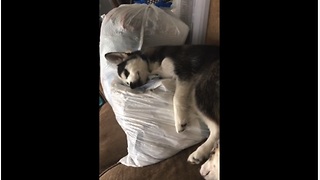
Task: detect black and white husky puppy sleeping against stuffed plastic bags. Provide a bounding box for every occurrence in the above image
[105,45,220,179]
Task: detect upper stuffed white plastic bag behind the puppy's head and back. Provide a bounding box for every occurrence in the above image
[100,4,189,105]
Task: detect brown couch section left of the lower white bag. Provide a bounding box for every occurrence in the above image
[99,102,127,173]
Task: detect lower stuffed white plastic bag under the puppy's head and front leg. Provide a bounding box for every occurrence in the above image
[109,78,209,167]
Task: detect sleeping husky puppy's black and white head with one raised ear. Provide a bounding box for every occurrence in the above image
[105,51,150,89]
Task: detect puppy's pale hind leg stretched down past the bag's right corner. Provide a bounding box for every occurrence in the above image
[188,112,219,164]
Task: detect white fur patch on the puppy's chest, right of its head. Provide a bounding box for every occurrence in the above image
[150,58,176,78]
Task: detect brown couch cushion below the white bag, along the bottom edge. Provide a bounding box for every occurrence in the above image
[100,143,203,180]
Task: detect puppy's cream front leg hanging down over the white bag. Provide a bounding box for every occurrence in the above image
[173,78,192,133]
